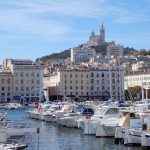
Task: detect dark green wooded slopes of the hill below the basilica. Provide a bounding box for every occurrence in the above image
[36,44,138,62]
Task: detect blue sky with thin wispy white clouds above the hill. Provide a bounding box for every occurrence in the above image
[0,0,150,64]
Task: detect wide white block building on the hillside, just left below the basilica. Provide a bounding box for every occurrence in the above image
[71,47,96,62]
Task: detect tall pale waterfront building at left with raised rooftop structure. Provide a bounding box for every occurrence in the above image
[4,59,43,101]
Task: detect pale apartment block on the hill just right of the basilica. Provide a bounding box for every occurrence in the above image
[107,43,124,58]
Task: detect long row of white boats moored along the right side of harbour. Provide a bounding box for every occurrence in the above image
[27,100,150,148]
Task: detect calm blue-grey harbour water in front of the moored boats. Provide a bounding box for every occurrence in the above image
[2,110,141,150]
